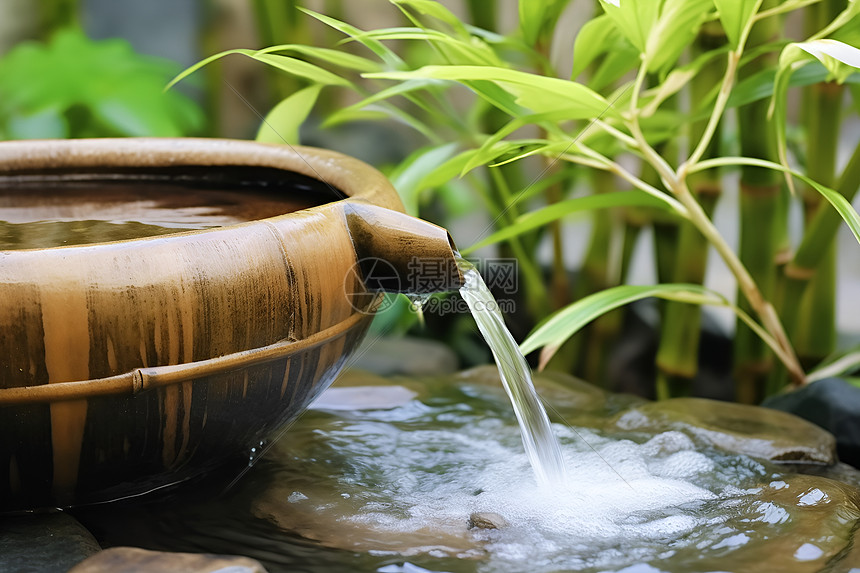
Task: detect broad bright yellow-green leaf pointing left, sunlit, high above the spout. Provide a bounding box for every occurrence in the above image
[366,66,618,119]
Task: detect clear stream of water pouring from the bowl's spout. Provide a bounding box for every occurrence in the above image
[457,255,564,485]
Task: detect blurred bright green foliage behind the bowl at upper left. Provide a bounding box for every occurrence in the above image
[0,29,203,139]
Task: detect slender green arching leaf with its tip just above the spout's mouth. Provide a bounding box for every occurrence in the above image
[462,190,671,255]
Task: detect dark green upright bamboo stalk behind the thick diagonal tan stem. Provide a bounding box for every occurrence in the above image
[734,0,784,404]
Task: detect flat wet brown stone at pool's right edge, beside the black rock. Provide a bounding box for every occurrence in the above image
[614,398,836,464]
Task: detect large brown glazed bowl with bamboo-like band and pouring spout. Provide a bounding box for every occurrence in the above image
[0,139,462,510]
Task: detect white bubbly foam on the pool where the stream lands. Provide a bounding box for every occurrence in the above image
[318,411,755,572]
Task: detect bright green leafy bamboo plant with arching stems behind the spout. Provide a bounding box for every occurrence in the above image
[177,0,860,402]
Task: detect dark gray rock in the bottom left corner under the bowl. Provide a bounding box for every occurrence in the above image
[0,512,101,573]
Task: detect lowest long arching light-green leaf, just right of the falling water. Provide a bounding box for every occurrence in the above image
[520,284,728,364]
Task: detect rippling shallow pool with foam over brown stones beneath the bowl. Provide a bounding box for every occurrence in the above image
[62,368,860,573]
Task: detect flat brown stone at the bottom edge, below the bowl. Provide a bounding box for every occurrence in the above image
[69,547,266,573]
